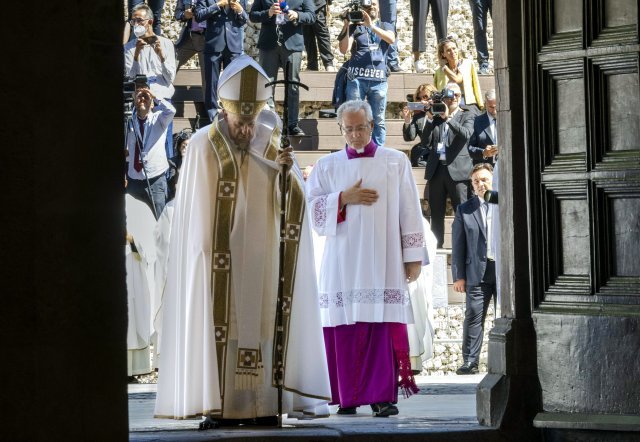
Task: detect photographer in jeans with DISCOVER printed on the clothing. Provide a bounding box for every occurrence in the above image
[338,0,396,146]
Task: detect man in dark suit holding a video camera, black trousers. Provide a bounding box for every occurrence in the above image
[422,83,474,248]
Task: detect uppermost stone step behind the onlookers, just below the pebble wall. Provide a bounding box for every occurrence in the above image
[173,69,495,103]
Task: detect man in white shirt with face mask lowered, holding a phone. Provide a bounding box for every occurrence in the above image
[124,4,176,158]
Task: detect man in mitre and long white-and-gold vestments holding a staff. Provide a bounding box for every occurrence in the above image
[155,56,331,426]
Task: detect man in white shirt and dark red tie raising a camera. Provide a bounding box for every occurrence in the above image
[127,88,176,219]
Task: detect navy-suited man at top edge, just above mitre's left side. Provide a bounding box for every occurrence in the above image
[195,0,249,121]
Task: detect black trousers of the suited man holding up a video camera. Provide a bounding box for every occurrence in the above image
[424,164,469,249]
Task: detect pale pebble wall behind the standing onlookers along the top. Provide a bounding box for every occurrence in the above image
[151,0,493,73]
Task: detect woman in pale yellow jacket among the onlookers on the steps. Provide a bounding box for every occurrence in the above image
[433,37,484,114]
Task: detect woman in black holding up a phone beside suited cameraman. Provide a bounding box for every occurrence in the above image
[402,83,437,167]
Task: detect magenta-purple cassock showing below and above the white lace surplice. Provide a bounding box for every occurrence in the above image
[323,141,419,408]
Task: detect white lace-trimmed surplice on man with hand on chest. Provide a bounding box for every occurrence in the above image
[307,147,429,327]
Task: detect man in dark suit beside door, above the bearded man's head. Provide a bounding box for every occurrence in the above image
[469,89,498,166]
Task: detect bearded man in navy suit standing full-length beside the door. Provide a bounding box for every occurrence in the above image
[451,163,497,374]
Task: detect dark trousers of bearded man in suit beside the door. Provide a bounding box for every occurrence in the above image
[462,261,497,365]
